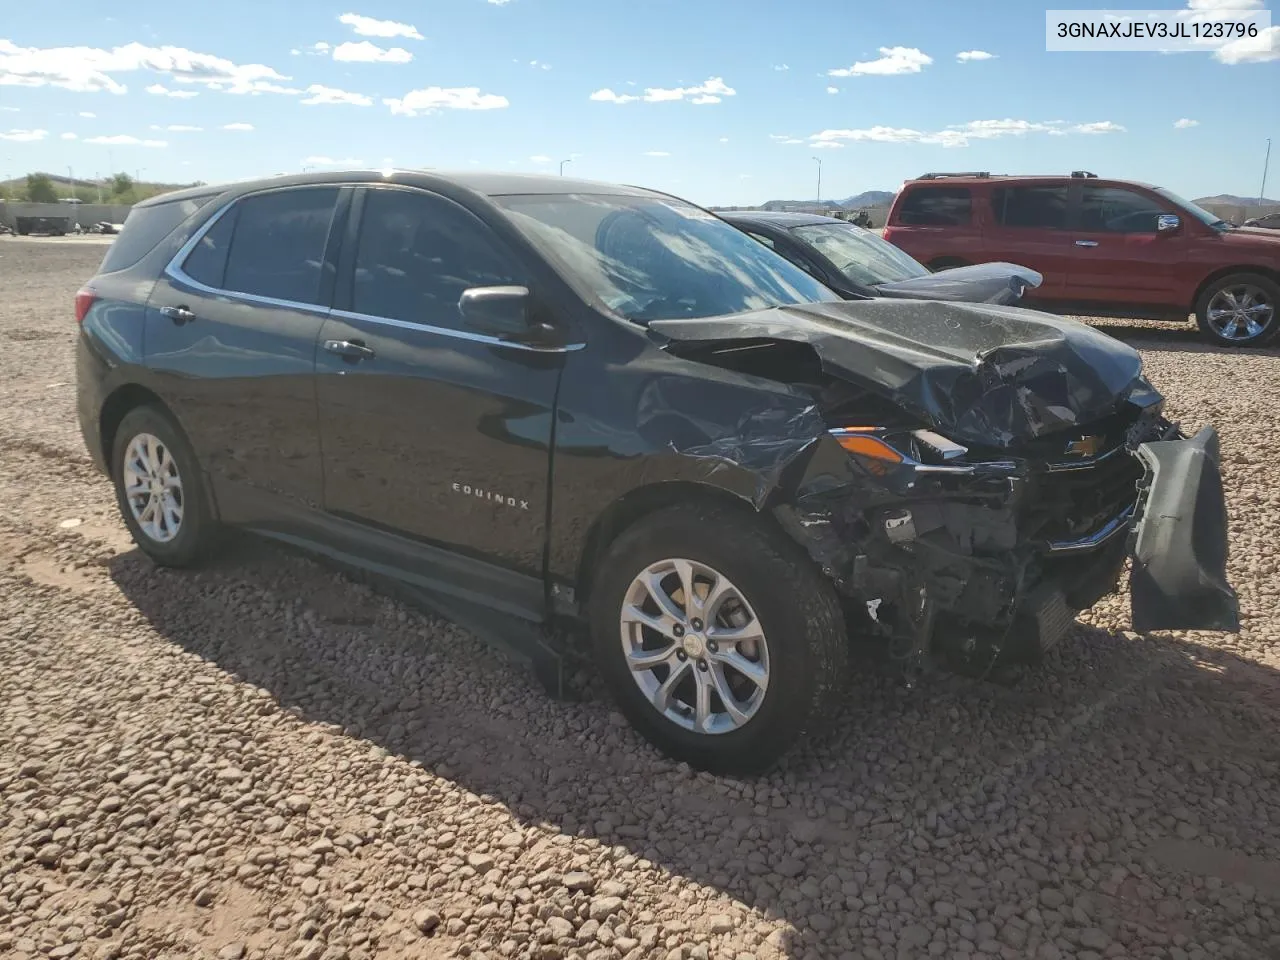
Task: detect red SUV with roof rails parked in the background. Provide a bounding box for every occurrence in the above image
[884,170,1280,347]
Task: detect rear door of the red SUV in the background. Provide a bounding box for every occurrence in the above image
[983,183,1073,303]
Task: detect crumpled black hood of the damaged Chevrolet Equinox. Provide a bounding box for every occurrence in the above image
[649,300,1142,447]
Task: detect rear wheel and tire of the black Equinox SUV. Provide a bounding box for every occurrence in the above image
[111,406,216,567]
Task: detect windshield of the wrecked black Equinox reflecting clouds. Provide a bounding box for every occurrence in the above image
[494,193,840,323]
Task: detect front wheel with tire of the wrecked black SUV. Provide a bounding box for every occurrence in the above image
[589,504,849,774]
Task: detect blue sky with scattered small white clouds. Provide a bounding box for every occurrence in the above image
[0,0,1280,205]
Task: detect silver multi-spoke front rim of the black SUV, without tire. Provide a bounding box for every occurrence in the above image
[621,558,769,733]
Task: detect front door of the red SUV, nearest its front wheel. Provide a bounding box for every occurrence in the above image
[1068,184,1188,307]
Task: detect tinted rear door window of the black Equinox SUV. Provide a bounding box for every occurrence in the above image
[219,187,339,303]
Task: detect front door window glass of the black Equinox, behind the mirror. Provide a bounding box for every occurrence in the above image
[351,189,525,330]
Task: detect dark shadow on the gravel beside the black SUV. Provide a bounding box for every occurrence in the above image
[109,536,1280,957]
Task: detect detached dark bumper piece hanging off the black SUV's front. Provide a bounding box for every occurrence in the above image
[1129,426,1240,634]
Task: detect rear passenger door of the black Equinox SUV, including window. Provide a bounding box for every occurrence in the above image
[145,186,344,522]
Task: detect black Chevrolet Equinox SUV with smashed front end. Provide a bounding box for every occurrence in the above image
[76,172,1238,772]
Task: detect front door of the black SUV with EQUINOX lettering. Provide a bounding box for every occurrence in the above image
[316,187,563,608]
